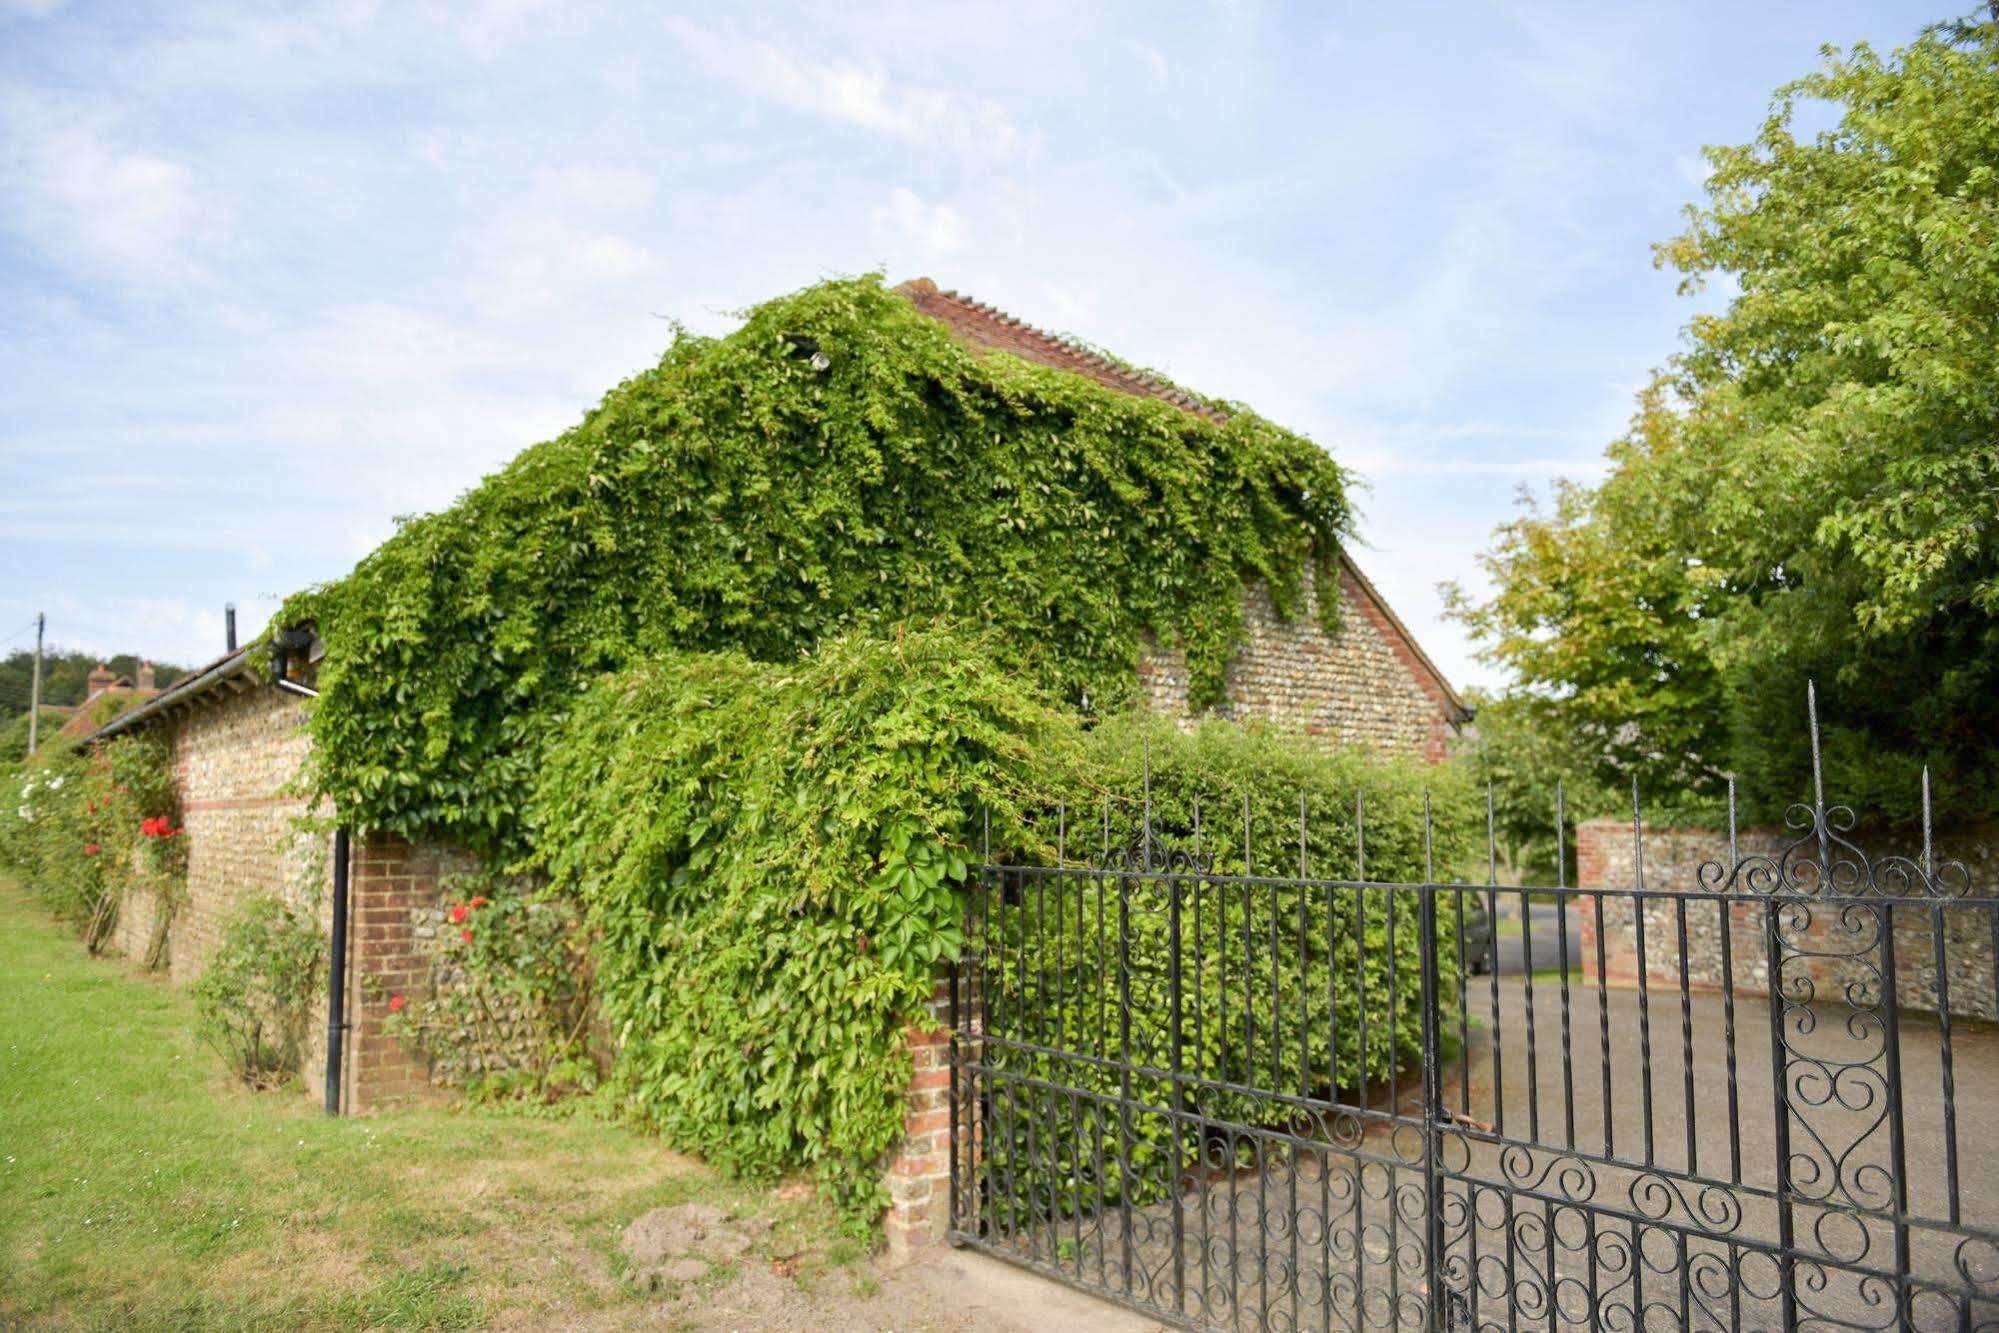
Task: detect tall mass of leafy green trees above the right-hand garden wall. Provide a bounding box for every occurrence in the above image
[1453,20,1999,817]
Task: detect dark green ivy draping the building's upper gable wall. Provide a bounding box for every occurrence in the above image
[289,276,1349,853]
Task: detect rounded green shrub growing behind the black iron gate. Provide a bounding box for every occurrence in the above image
[980,715,1479,1221]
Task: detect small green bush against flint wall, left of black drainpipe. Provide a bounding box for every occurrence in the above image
[190,897,326,1087]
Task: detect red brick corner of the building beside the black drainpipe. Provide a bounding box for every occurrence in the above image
[346,837,440,1113]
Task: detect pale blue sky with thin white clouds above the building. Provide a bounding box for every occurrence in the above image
[0,0,1951,683]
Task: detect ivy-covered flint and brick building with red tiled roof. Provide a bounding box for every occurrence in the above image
[77,280,1469,1223]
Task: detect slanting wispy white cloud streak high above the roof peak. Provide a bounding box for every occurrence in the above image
[668,18,1037,162]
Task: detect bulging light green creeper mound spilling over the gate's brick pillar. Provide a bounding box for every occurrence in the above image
[530,630,1073,1231]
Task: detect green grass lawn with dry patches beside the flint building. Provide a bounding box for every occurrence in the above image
[0,877,870,1331]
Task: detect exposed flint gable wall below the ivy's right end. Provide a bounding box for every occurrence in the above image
[1137,570,1451,761]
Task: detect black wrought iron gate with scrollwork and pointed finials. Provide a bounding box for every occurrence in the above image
[950,695,1999,1329]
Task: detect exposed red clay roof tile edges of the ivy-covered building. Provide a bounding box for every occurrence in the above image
[896,278,1471,723]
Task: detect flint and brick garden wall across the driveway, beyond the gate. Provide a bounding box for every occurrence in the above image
[1575,819,1999,1019]
